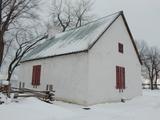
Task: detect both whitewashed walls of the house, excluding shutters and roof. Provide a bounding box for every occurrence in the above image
[19,12,142,105]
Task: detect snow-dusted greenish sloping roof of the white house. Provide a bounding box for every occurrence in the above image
[22,12,121,61]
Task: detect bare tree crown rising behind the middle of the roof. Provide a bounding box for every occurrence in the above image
[52,0,93,32]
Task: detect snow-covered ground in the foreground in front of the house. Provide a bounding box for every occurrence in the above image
[0,90,160,120]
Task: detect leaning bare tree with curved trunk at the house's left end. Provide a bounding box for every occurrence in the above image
[4,31,48,97]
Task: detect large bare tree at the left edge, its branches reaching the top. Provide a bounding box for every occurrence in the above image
[0,0,37,65]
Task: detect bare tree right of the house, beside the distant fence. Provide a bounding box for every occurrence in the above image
[137,41,160,90]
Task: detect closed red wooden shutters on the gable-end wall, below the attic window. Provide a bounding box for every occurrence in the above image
[116,66,125,90]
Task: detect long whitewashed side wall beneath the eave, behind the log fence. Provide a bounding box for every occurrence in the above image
[20,53,88,104]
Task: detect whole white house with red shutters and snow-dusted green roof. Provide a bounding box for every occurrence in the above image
[19,11,142,105]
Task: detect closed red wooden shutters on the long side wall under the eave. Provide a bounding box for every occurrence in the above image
[32,65,41,86]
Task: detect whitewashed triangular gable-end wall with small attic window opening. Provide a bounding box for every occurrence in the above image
[88,16,142,104]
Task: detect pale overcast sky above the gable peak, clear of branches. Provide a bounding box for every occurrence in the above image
[40,0,160,47]
